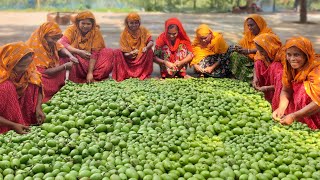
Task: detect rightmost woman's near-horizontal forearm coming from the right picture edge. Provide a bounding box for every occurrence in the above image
[280,101,320,125]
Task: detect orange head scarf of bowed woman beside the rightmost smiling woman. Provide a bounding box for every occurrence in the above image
[253,33,281,66]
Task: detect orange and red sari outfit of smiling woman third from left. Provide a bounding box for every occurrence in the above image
[60,11,113,83]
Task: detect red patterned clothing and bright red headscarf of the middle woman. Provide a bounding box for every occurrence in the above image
[155,18,193,78]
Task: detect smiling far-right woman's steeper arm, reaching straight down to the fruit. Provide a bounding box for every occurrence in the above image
[272,86,293,120]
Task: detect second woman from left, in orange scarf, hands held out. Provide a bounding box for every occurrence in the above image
[26,22,78,102]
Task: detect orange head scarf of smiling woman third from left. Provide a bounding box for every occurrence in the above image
[63,11,105,52]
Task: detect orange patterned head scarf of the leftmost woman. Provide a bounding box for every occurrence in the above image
[0,42,41,96]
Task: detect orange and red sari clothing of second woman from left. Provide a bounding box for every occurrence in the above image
[26,22,66,102]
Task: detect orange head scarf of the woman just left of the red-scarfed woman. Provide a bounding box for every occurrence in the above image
[120,13,151,58]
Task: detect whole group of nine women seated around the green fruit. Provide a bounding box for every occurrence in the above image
[0,11,320,133]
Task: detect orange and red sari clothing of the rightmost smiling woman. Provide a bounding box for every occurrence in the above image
[282,37,320,129]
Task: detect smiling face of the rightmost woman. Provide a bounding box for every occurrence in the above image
[286,46,308,70]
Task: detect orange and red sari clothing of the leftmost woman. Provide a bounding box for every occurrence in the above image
[0,42,41,133]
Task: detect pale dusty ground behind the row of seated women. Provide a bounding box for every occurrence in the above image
[0,12,320,75]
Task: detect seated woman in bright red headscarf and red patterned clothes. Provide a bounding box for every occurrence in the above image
[154,18,193,78]
